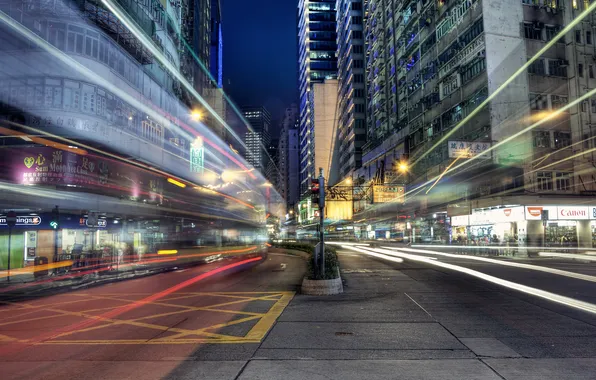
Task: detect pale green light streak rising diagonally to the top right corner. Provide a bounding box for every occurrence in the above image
[412,2,596,166]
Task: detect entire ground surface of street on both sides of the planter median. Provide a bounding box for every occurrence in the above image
[0,250,596,380]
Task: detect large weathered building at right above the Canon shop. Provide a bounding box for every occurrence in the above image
[361,0,596,245]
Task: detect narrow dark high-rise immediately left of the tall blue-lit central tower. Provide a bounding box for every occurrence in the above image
[278,104,300,209]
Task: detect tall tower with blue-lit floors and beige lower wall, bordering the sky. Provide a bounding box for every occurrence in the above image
[297,0,337,194]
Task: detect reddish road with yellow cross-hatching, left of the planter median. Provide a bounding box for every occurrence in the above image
[0,255,306,379]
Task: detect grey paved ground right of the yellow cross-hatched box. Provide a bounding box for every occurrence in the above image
[224,251,596,380]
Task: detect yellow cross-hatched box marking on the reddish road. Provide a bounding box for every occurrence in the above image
[0,291,294,345]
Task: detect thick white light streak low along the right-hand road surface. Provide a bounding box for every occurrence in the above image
[358,248,596,314]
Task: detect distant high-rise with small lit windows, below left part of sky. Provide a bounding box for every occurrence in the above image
[242,107,271,175]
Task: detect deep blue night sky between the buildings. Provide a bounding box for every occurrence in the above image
[221,0,297,136]
